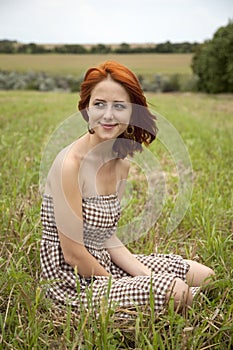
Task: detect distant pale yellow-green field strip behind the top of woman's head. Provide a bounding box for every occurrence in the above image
[0,54,192,76]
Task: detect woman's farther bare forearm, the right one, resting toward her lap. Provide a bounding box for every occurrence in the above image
[106,235,151,276]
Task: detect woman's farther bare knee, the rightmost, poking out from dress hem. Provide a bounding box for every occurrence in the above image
[186,260,215,287]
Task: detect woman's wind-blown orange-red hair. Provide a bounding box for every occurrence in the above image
[78,61,158,158]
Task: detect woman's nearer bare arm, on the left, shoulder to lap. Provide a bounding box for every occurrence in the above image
[50,150,110,278]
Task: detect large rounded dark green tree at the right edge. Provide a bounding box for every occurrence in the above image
[192,21,233,93]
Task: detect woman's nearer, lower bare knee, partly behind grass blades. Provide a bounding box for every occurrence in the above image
[166,277,193,310]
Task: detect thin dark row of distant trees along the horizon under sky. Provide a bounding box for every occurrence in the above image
[0,40,200,54]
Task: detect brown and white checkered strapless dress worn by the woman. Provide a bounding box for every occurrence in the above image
[41,194,195,312]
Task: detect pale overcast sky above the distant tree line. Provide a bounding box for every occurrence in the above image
[0,0,233,44]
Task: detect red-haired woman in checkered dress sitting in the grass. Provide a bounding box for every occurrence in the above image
[41,61,214,312]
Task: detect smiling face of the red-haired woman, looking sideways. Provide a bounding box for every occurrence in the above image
[87,77,132,140]
